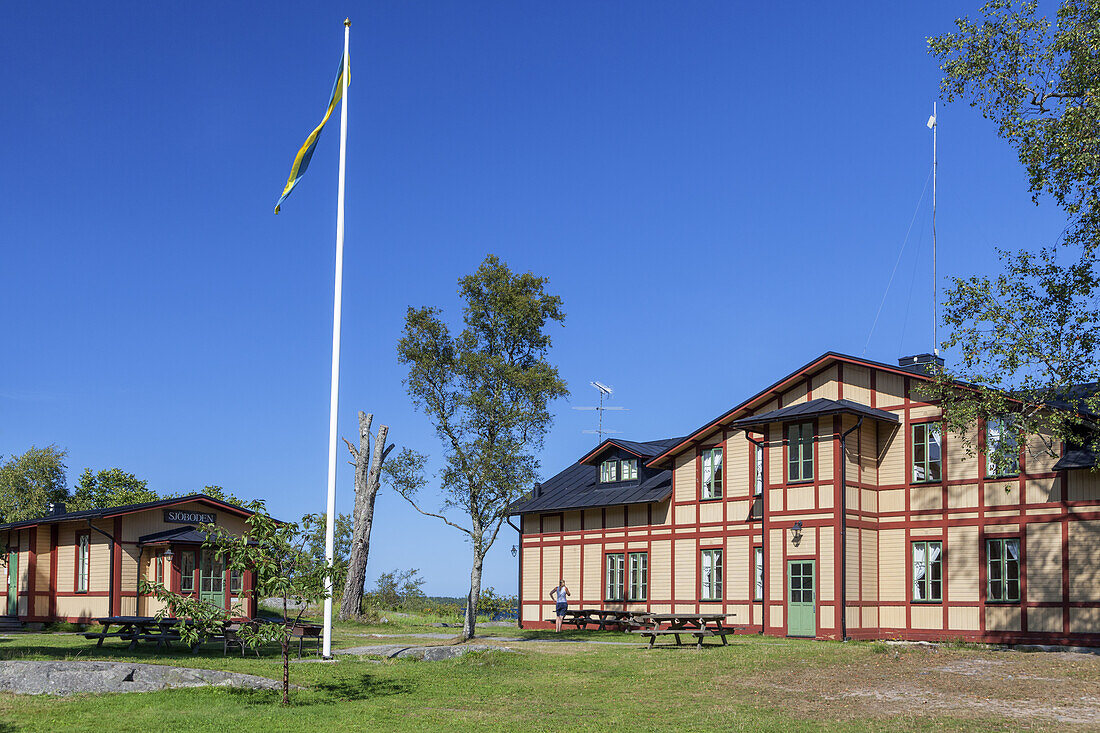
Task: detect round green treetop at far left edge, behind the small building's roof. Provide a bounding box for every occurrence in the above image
[0,445,68,522]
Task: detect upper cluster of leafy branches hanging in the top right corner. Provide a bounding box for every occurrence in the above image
[928,0,1100,252]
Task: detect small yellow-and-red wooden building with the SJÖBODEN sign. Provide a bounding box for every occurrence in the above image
[0,494,256,623]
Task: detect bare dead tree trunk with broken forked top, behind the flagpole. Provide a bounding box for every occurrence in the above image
[340,411,393,621]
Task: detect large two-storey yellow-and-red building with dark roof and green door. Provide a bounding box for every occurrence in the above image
[513,352,1100,645]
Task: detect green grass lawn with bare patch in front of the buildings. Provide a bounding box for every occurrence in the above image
[0,617,1100,732]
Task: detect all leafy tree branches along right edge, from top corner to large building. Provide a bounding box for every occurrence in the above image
[926,0,1100,453]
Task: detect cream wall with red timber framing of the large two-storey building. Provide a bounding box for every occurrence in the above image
[520,359,1100,643]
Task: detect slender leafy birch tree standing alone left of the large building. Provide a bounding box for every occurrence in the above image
[386,254,568,641]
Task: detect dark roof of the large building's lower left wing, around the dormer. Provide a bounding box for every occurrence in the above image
[509,438,680,514]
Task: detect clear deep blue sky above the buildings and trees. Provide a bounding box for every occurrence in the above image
[0,1,1064,594]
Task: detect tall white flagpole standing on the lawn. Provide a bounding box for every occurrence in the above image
[321,19,351,659]
